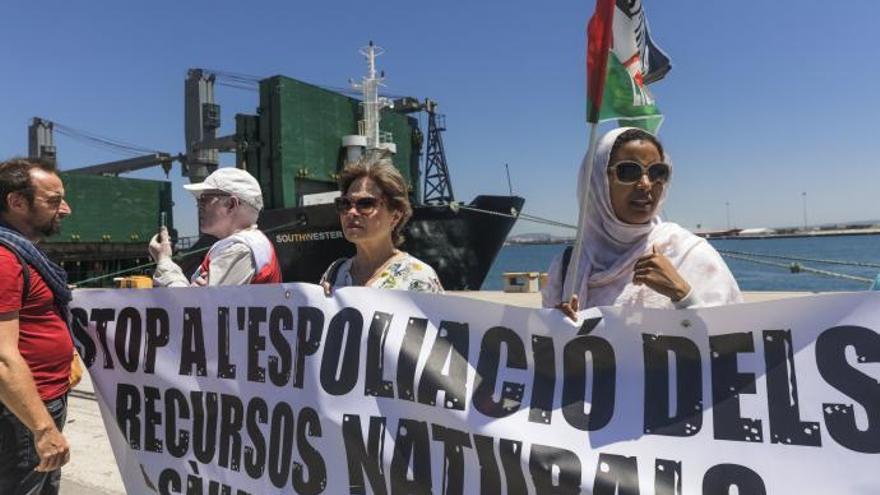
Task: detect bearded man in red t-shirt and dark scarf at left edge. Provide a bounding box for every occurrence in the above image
[0,159,73,495]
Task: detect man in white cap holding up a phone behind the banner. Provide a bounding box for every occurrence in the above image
[150,168,281,287]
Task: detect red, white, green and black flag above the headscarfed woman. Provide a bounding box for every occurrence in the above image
[587,0,672,131]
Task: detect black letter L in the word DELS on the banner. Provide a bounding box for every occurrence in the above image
[764,330,822,447]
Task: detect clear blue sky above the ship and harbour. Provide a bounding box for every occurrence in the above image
[0,0,880,238]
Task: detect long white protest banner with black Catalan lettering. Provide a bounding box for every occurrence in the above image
[72,284,880,495]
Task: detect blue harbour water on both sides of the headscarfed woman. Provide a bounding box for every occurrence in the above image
[483,235,880,292]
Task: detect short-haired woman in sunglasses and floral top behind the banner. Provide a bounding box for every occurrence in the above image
[321,154,443,294]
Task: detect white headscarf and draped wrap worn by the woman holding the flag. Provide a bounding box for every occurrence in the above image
[543,127,741,308]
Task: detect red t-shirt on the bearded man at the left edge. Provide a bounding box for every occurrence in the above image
[0,246,73,400]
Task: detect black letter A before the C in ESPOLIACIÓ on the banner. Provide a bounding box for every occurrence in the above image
[419,321,470,411]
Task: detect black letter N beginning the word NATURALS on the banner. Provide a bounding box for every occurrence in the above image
[342,414,386,495]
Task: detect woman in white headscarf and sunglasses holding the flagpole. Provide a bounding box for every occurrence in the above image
[542,128,742,319]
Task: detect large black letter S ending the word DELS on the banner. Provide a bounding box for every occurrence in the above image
[816,325,880,454]
